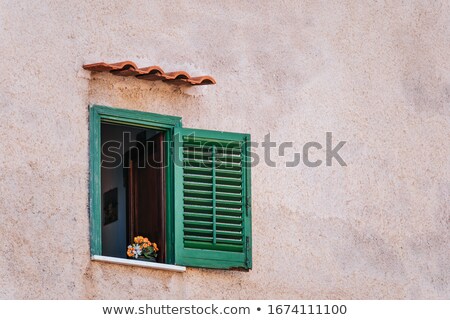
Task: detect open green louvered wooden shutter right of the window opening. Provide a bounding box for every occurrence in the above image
[174,128,251,269]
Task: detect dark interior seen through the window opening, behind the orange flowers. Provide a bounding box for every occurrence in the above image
[101,122,166,262]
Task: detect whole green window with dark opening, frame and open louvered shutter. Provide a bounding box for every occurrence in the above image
[90,106,251,269]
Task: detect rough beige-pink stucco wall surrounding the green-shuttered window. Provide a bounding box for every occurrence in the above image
[0,1,450,299]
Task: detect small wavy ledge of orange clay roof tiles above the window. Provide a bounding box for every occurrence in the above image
[83,61,216,86]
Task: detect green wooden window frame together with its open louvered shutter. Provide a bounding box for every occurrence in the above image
[89,105,252,270]
